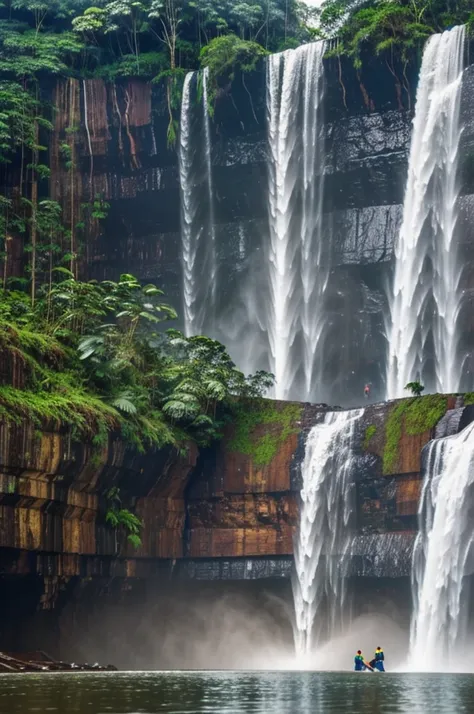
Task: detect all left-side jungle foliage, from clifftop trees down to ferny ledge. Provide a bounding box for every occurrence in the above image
[0,5,282,545]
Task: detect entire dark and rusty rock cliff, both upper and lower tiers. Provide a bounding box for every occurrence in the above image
[0,47,474,652]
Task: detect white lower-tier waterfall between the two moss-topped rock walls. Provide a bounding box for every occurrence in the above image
[293,409,364,656]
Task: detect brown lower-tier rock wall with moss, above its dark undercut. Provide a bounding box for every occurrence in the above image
[0,395,472,584]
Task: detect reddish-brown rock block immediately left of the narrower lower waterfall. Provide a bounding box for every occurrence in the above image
[187,402,302,558]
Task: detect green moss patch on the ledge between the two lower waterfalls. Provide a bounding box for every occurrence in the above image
[383,394,447,474]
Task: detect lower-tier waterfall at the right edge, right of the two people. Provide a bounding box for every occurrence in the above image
[410,422,474,671]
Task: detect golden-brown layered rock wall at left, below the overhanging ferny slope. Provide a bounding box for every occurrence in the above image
[0,424,197,574]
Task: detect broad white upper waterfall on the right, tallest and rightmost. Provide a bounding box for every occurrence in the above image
[387,27,465,399]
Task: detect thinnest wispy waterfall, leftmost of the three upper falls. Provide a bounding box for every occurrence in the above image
[179,70,217,336]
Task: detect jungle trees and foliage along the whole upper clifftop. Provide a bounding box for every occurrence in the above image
[0,0,468,156]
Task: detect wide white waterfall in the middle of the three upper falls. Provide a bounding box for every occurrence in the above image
[266,42,328,399]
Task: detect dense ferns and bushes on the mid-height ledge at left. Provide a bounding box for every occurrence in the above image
[0,269,272,450]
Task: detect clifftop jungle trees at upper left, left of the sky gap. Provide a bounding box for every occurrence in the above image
[0,0,313,152]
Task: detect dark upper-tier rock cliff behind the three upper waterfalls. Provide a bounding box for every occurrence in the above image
[37,51,474,406]
